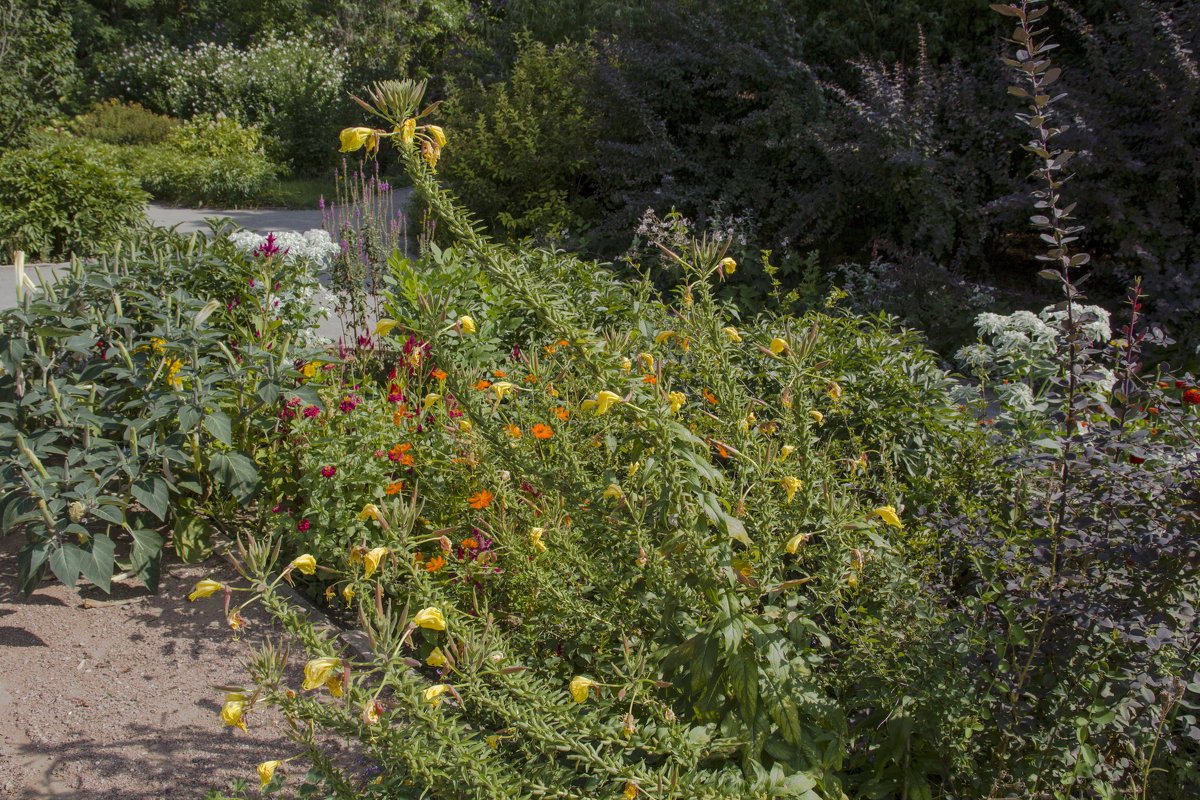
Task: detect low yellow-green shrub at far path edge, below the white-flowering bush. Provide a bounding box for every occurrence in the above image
[136,118,282,206]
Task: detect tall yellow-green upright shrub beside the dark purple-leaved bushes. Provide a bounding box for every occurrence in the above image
[443,38,599,241]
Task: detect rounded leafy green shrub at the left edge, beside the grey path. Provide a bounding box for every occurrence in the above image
[0,138,148,259]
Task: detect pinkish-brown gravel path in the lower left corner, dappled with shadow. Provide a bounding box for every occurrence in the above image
[0,536,302,800]
